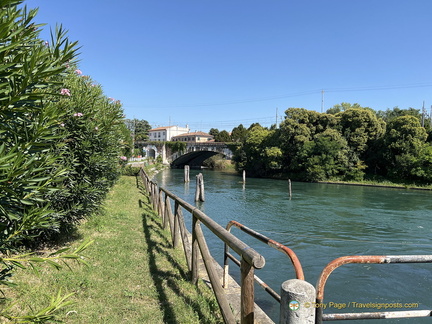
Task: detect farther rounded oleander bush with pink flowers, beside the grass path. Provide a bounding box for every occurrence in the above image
[48,66,132,227]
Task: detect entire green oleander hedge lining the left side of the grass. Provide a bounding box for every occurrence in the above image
[0,0,131,321]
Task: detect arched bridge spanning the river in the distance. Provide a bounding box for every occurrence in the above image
[143,142,233,168]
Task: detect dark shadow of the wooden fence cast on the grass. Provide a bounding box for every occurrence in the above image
[140,201,222,323]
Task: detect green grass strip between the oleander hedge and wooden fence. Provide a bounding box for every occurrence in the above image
[5,176,223,324]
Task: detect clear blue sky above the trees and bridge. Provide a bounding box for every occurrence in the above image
[24,0,432,131]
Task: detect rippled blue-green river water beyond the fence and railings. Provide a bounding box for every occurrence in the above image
[155,170,432,324]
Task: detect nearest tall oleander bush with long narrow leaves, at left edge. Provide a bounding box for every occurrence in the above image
[0,0,76,248]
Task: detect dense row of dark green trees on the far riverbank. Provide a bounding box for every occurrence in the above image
[211,103,432,184]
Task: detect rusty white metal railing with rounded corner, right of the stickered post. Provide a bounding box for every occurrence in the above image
[316,255,432,324]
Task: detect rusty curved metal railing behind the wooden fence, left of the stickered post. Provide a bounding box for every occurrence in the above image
[223,220,304,303]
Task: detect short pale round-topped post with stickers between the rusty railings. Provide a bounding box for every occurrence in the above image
[279,279,316,324]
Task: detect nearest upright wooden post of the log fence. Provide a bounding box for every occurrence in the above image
[240,257,255,324]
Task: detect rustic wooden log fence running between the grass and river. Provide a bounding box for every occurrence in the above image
[139,168,265,324]
